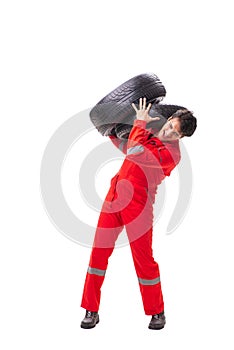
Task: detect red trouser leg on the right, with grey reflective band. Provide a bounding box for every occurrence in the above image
[127,228,164,315]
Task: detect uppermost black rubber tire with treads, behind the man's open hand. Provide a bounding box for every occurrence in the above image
[90,73,166,136]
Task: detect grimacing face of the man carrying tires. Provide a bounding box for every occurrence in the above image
[156,117,182,141]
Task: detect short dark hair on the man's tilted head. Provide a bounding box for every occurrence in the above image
[172,109,197,136]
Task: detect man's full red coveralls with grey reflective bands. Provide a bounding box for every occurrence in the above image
[81,120,180,315]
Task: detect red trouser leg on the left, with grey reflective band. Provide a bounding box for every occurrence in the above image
[81,206,123,311]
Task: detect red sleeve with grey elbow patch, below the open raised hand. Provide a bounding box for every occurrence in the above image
[127,120,180,175]
